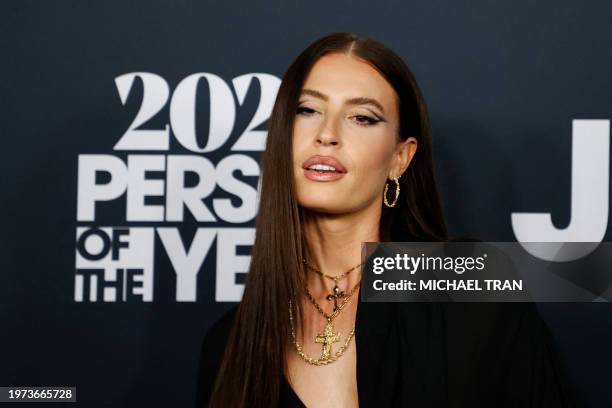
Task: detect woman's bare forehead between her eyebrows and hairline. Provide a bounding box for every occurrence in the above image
[303,54,396,112]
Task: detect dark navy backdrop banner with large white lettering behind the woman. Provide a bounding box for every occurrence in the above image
[0,0,612,407]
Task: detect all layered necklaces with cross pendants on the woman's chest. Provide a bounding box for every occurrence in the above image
[289,259,363,365]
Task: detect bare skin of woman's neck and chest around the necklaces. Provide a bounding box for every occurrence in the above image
[287,201,381,408]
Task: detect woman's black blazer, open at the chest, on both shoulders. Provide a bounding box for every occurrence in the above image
[197,297,575,408]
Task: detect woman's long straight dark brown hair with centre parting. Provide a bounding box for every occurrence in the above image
[210,33,447,408]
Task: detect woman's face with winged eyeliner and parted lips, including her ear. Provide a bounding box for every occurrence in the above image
[293,54,416,214]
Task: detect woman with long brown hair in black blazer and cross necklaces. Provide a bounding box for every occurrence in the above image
[198,33,571,407]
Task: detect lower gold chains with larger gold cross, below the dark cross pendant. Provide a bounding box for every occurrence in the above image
[289,281,361,366]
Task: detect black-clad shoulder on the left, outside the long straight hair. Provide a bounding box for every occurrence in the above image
[196,305,238,408]
